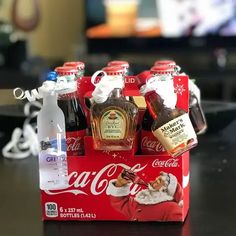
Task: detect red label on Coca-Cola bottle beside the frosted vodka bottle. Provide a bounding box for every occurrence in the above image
[66,129,86,156]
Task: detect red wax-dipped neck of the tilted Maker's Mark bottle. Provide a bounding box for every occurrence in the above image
[145,90,168,120]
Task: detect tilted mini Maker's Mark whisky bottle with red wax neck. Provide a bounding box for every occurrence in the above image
[145,91,197,157]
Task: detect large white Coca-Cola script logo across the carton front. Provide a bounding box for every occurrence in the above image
[45,163,147,195]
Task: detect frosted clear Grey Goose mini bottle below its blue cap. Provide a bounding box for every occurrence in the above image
[37,90,68,190]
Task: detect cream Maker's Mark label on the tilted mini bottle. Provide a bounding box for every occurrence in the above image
[153,113,197,155]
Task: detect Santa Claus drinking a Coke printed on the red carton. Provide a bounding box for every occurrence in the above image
[109,170,183,221]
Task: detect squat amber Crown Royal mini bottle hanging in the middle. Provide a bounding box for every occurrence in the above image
[91,88,138,150]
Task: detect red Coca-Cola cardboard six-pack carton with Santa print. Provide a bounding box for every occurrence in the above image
[41,76,189,222]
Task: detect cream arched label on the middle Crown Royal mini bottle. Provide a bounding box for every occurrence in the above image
[100,109,126,140]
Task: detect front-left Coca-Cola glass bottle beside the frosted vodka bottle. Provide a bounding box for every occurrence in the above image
[55,66,88,156]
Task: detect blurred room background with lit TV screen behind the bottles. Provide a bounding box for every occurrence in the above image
[0,0,236,137]
